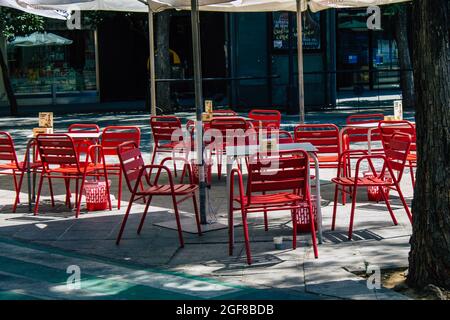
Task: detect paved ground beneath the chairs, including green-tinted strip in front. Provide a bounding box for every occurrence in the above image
[0,113,413,299]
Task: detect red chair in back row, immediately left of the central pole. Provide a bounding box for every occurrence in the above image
[150,116,187,177]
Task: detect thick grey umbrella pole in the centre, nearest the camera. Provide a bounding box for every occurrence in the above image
[191,0,207,224]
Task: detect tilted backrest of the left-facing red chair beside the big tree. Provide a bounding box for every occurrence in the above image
[383,132,411,181]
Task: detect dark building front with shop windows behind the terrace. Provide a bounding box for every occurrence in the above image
[0,10,400,113]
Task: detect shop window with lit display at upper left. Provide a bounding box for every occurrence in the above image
[8,30,96,94]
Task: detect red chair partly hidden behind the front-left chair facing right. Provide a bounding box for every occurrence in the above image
[101,126,141,210]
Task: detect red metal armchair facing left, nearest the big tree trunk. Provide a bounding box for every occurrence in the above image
[331,133,412,240]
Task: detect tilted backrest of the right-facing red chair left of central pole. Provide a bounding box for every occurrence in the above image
[116,141,145,192]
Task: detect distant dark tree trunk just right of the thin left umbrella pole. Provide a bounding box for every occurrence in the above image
[155,11,172,113]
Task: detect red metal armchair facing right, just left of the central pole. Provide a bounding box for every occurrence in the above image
[116,142,201,247]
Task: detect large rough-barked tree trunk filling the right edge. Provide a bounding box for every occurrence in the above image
[408,0,450,288]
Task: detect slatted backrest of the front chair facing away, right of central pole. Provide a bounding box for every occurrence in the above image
[247,150,309,199]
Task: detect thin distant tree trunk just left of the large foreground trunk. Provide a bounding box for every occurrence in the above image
[395,5,414,107]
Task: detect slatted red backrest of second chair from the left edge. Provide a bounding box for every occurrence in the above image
[36,134,80,171]
